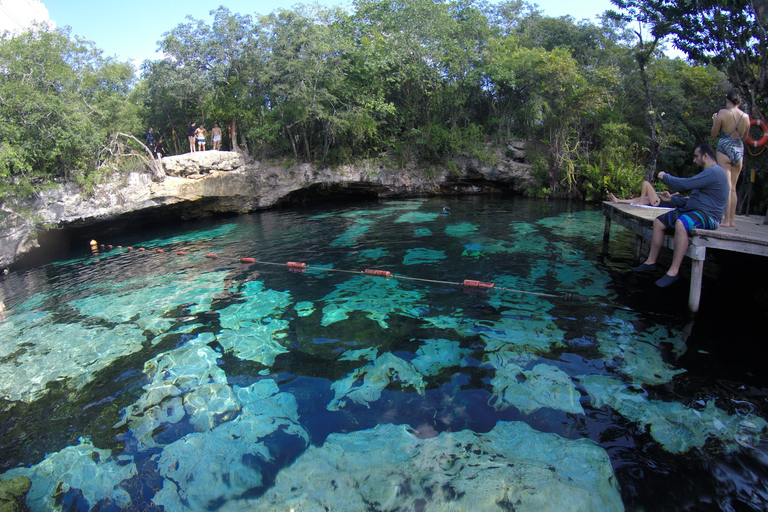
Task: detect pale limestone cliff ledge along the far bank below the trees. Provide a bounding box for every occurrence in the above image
[0,143,530,267]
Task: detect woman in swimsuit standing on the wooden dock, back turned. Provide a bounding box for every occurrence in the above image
[712,92,749,228]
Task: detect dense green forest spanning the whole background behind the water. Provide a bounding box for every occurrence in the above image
[0,0,768,211]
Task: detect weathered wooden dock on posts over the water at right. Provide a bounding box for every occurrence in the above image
[603,201,768,312]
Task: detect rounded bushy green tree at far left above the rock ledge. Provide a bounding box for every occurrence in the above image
[0,29,133,202]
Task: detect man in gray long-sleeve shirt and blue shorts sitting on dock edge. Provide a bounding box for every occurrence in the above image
[632,144,730,288]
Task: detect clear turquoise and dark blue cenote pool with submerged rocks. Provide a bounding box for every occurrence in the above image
[0,198,768,512]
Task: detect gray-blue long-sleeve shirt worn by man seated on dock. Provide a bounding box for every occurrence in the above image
[662,164,730,223]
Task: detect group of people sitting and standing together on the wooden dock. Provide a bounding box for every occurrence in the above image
[610,92,750,288]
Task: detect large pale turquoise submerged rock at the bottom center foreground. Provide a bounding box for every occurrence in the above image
[220,422,624,512]
